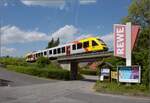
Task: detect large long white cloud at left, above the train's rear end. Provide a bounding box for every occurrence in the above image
[1,25,49,44]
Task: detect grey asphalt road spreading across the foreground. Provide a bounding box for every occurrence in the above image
[0,69,150,103]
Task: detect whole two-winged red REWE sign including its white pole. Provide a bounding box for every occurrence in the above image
[114,22,140,66]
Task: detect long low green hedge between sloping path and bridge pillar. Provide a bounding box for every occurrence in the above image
[7,65,70,80]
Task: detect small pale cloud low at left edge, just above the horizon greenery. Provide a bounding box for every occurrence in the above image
[1,47,17,56]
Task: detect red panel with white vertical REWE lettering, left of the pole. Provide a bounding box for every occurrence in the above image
[114,24,126,58]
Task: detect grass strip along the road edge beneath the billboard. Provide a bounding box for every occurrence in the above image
[94,81,150,96]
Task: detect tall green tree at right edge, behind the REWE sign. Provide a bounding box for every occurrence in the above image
[122,0,150,87]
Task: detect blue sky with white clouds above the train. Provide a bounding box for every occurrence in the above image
[0,0,131,57]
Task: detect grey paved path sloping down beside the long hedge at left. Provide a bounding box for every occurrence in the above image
[0,67,57,86]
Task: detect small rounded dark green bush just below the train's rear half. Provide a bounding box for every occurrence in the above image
[36,57,50,68]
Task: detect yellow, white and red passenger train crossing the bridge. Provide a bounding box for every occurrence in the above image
[25,37,108,62]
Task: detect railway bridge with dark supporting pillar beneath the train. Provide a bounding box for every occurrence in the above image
[57,51,113,80]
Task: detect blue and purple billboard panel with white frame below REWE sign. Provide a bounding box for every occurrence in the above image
[118,66,141,83]
